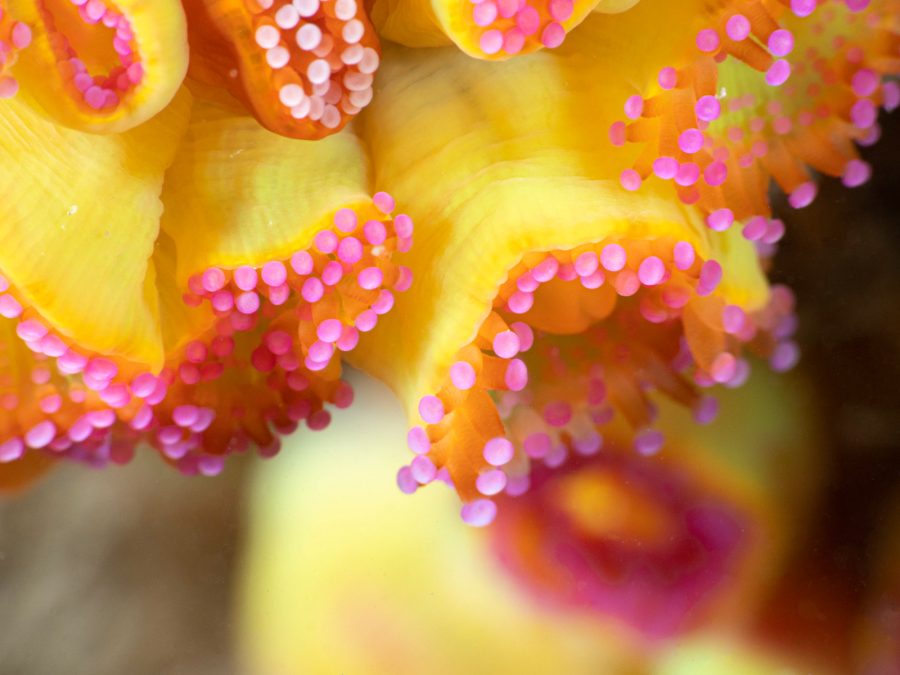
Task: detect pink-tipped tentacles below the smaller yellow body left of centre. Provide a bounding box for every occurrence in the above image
[153,192,412,473]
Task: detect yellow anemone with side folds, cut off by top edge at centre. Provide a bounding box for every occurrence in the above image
[372,0,638,61]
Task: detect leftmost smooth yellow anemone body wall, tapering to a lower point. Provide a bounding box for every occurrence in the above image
[0,92,190,369]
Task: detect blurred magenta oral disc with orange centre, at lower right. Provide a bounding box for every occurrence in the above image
[489,443,764,639]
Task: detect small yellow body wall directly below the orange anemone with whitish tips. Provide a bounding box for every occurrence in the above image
[162,84,374,286]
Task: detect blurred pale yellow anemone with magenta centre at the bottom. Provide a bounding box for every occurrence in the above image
[237,373,819,675]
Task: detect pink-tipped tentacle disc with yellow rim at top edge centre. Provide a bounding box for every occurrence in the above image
[436,0,597,60]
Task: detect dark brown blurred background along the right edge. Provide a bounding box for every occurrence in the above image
[752,115,900,672]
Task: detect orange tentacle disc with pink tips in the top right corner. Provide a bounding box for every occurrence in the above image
[609,0,900,230]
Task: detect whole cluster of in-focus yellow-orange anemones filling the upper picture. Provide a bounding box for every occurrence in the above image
[0,0,900,544]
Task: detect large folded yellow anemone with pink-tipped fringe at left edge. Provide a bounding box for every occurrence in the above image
[0,85,412,486]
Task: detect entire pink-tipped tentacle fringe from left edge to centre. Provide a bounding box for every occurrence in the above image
[0,193,412,475]
